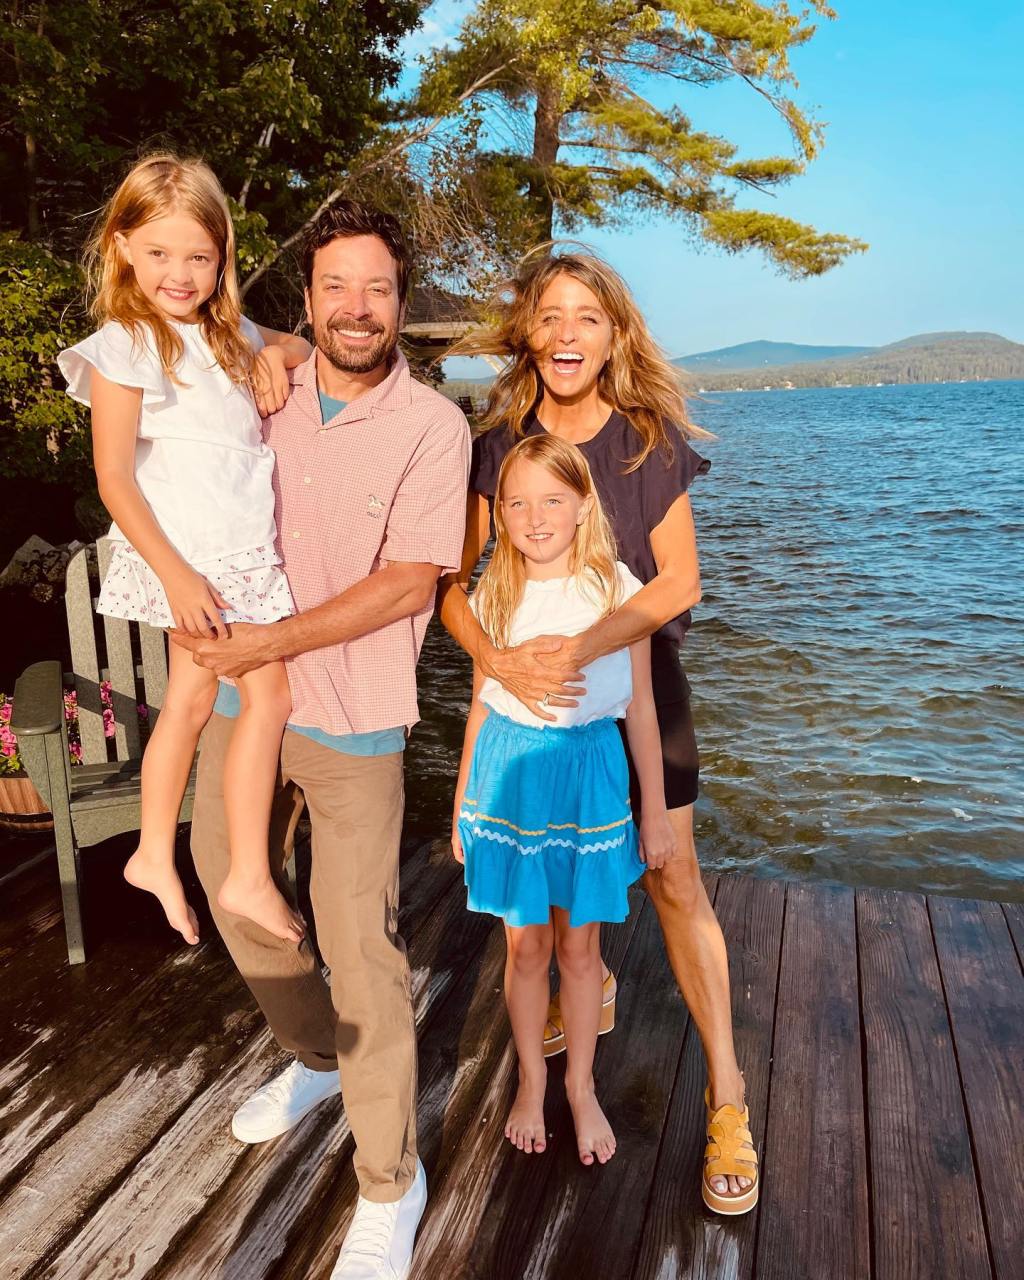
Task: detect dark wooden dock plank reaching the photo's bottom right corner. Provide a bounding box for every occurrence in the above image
[928,897,1024,1280]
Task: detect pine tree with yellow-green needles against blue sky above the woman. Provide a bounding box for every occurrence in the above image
[411,0,865,276]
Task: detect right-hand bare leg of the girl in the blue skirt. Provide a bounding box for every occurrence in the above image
[553,908,616,1165]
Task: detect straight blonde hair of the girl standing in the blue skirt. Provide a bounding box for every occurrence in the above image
[476,435,621,649]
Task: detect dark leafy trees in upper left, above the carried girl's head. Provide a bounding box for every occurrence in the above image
[0,0,419,305]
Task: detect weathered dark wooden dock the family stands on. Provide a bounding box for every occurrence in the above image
[0,824,1024,1280]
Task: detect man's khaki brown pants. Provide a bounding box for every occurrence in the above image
[192,716,416,1203]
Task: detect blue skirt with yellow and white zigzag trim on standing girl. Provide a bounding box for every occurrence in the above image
[458,712,645,928]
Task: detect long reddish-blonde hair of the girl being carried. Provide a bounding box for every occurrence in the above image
[86,152,253,384]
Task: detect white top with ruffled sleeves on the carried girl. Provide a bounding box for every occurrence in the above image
[58,319,276,567]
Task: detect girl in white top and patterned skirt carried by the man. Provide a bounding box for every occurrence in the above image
[59,155,310,943]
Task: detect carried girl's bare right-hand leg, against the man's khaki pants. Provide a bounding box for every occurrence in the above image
[216,662,305,942]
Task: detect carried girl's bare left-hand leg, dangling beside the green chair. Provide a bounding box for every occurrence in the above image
[124,645,216,946]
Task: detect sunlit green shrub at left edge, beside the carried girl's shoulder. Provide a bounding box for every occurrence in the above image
[0,233,90,483]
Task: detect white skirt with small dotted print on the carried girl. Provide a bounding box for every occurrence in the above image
[96,543,296,627]
